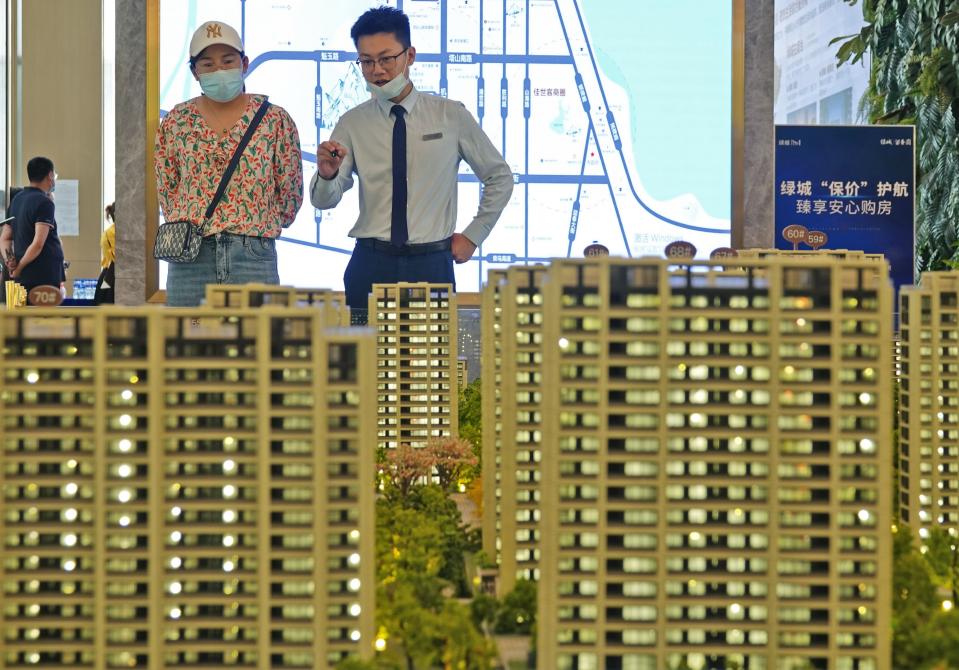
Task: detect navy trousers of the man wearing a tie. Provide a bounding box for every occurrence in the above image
[343,245,456,311]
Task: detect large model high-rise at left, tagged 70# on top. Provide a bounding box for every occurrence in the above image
[0,306,375,669]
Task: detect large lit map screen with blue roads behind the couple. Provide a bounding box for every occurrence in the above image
[160,0,733,291]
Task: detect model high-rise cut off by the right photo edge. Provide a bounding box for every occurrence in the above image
[899,272,959,538]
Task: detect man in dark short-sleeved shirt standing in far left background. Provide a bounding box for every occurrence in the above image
[7,156,64,291]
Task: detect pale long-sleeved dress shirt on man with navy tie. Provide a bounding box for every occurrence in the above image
[310,88,513,246]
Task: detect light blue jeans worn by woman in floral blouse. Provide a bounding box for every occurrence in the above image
[166,233,280,307]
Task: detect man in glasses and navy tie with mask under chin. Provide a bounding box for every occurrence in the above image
[310,6,513,318]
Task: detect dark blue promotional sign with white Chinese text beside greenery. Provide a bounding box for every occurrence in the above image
[775,126,916,288]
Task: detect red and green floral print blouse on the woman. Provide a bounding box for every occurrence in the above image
[154,95,303,237]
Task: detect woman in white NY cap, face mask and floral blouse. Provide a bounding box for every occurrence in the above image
[154,21,303,306]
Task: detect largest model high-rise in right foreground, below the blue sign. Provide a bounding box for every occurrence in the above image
[496,256,892,670]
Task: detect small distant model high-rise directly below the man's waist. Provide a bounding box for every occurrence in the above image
[369,283,459,448]
